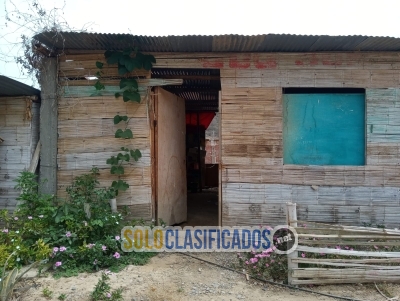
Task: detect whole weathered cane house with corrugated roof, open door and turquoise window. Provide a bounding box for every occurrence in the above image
[35,32,400,227]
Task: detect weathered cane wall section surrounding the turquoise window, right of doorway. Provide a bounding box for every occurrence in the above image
[219,53,400,227]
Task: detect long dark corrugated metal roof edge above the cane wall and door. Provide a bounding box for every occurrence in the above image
[34,32,400,52]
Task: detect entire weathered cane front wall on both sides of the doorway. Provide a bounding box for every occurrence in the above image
[58,52,400,226]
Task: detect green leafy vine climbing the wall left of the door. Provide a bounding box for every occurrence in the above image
[94,49,156,196]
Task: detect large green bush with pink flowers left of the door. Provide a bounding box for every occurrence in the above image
[0,168,152,275]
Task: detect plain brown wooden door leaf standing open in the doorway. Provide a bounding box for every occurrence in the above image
[155,87,187,225]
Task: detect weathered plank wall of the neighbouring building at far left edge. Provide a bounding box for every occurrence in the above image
[0,97,40,211]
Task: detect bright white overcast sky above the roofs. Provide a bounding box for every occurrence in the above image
[0,0,400,89]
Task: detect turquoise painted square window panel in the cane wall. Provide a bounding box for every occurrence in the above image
[283,93,365,165]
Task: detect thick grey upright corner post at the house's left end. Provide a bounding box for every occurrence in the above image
[39,58,58,195]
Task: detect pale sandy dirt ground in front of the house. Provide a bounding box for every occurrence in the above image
[19,253,400,301]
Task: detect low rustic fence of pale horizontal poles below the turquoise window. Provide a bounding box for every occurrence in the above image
[286,203,400,285]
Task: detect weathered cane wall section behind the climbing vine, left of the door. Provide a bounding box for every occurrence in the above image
[57,54,152,220]
